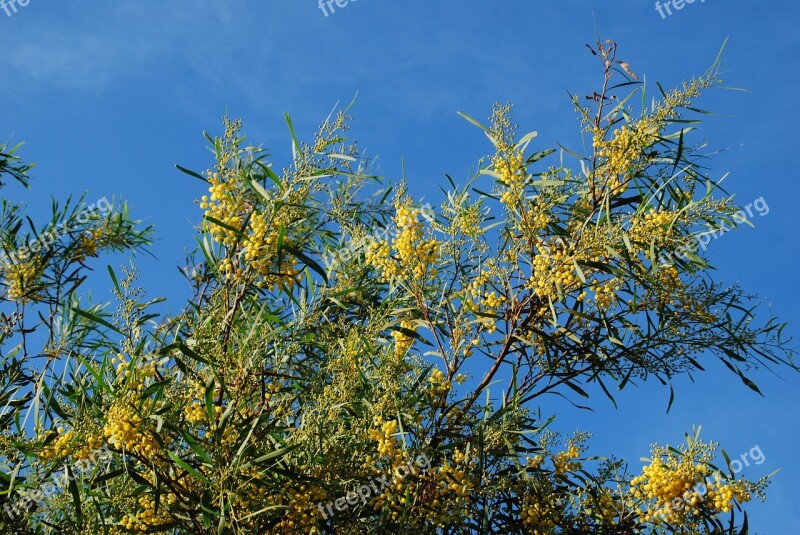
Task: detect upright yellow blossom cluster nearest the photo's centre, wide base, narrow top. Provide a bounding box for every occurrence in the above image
[366,198,440,280]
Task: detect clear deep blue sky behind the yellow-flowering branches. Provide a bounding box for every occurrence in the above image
[0,0,800,535]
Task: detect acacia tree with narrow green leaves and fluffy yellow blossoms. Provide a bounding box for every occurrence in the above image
[0,41,794,535]
